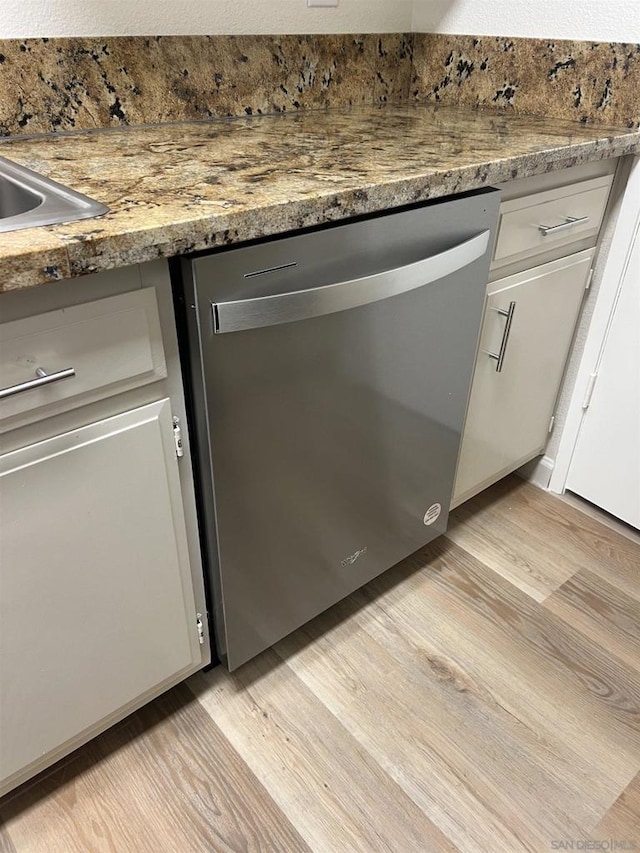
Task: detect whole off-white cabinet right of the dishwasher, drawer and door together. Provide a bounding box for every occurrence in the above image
[451,160,617,507]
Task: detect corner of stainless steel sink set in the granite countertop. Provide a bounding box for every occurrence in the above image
[0,157,109,232]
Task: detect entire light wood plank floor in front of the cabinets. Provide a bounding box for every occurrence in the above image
[0,477,640,853]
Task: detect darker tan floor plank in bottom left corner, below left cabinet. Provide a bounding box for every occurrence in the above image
[0,685,309,853]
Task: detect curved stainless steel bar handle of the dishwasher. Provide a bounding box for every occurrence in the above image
[211,231,491,334]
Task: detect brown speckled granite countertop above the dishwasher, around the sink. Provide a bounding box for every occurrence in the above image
[0,104,640,292]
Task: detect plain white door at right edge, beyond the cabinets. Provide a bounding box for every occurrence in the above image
[566,229,640,528]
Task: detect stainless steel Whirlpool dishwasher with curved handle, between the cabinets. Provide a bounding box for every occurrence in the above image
[176,189,499,669]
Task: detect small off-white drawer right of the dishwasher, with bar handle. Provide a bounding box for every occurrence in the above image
[494,175,613,266]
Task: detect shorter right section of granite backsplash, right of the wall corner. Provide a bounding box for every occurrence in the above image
[411,33,640,127]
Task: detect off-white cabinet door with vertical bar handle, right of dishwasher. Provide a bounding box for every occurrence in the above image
[452,250,593,506]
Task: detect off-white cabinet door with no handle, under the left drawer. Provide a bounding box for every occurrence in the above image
[0,400,201,787]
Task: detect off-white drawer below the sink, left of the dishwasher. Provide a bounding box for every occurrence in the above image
[0,288,167,431]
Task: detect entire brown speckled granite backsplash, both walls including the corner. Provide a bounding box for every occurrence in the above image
[0,33,640,136]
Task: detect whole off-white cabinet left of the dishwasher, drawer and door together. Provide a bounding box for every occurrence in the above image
[0,262,210,795]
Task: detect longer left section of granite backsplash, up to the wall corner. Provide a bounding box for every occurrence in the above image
[0,33,413,136]
